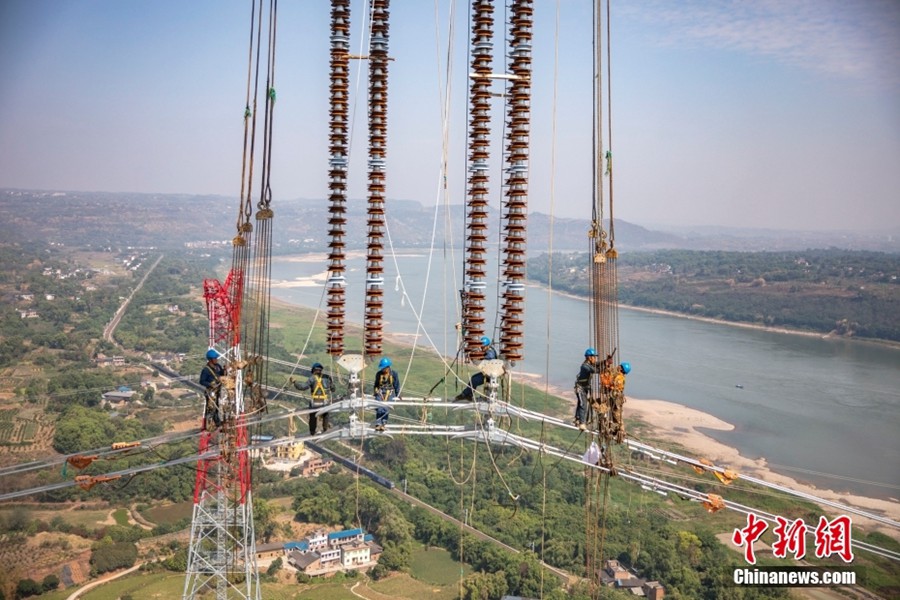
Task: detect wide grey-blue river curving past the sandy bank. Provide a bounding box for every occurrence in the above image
[272,251,900,499]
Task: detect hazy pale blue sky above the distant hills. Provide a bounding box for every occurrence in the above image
[0,0,900,231]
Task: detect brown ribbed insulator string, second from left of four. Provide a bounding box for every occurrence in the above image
[363,0,390,358]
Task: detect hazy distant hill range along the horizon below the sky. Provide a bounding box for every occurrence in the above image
[0,189,900,254]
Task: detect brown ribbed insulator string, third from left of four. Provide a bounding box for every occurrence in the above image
[462,0,494,362]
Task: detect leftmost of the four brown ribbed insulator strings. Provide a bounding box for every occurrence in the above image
[325,0,350,356]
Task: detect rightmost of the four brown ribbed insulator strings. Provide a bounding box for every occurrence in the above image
[500,0,534,365]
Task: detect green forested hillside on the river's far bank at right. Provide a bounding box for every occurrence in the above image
[528,249,900,341]
